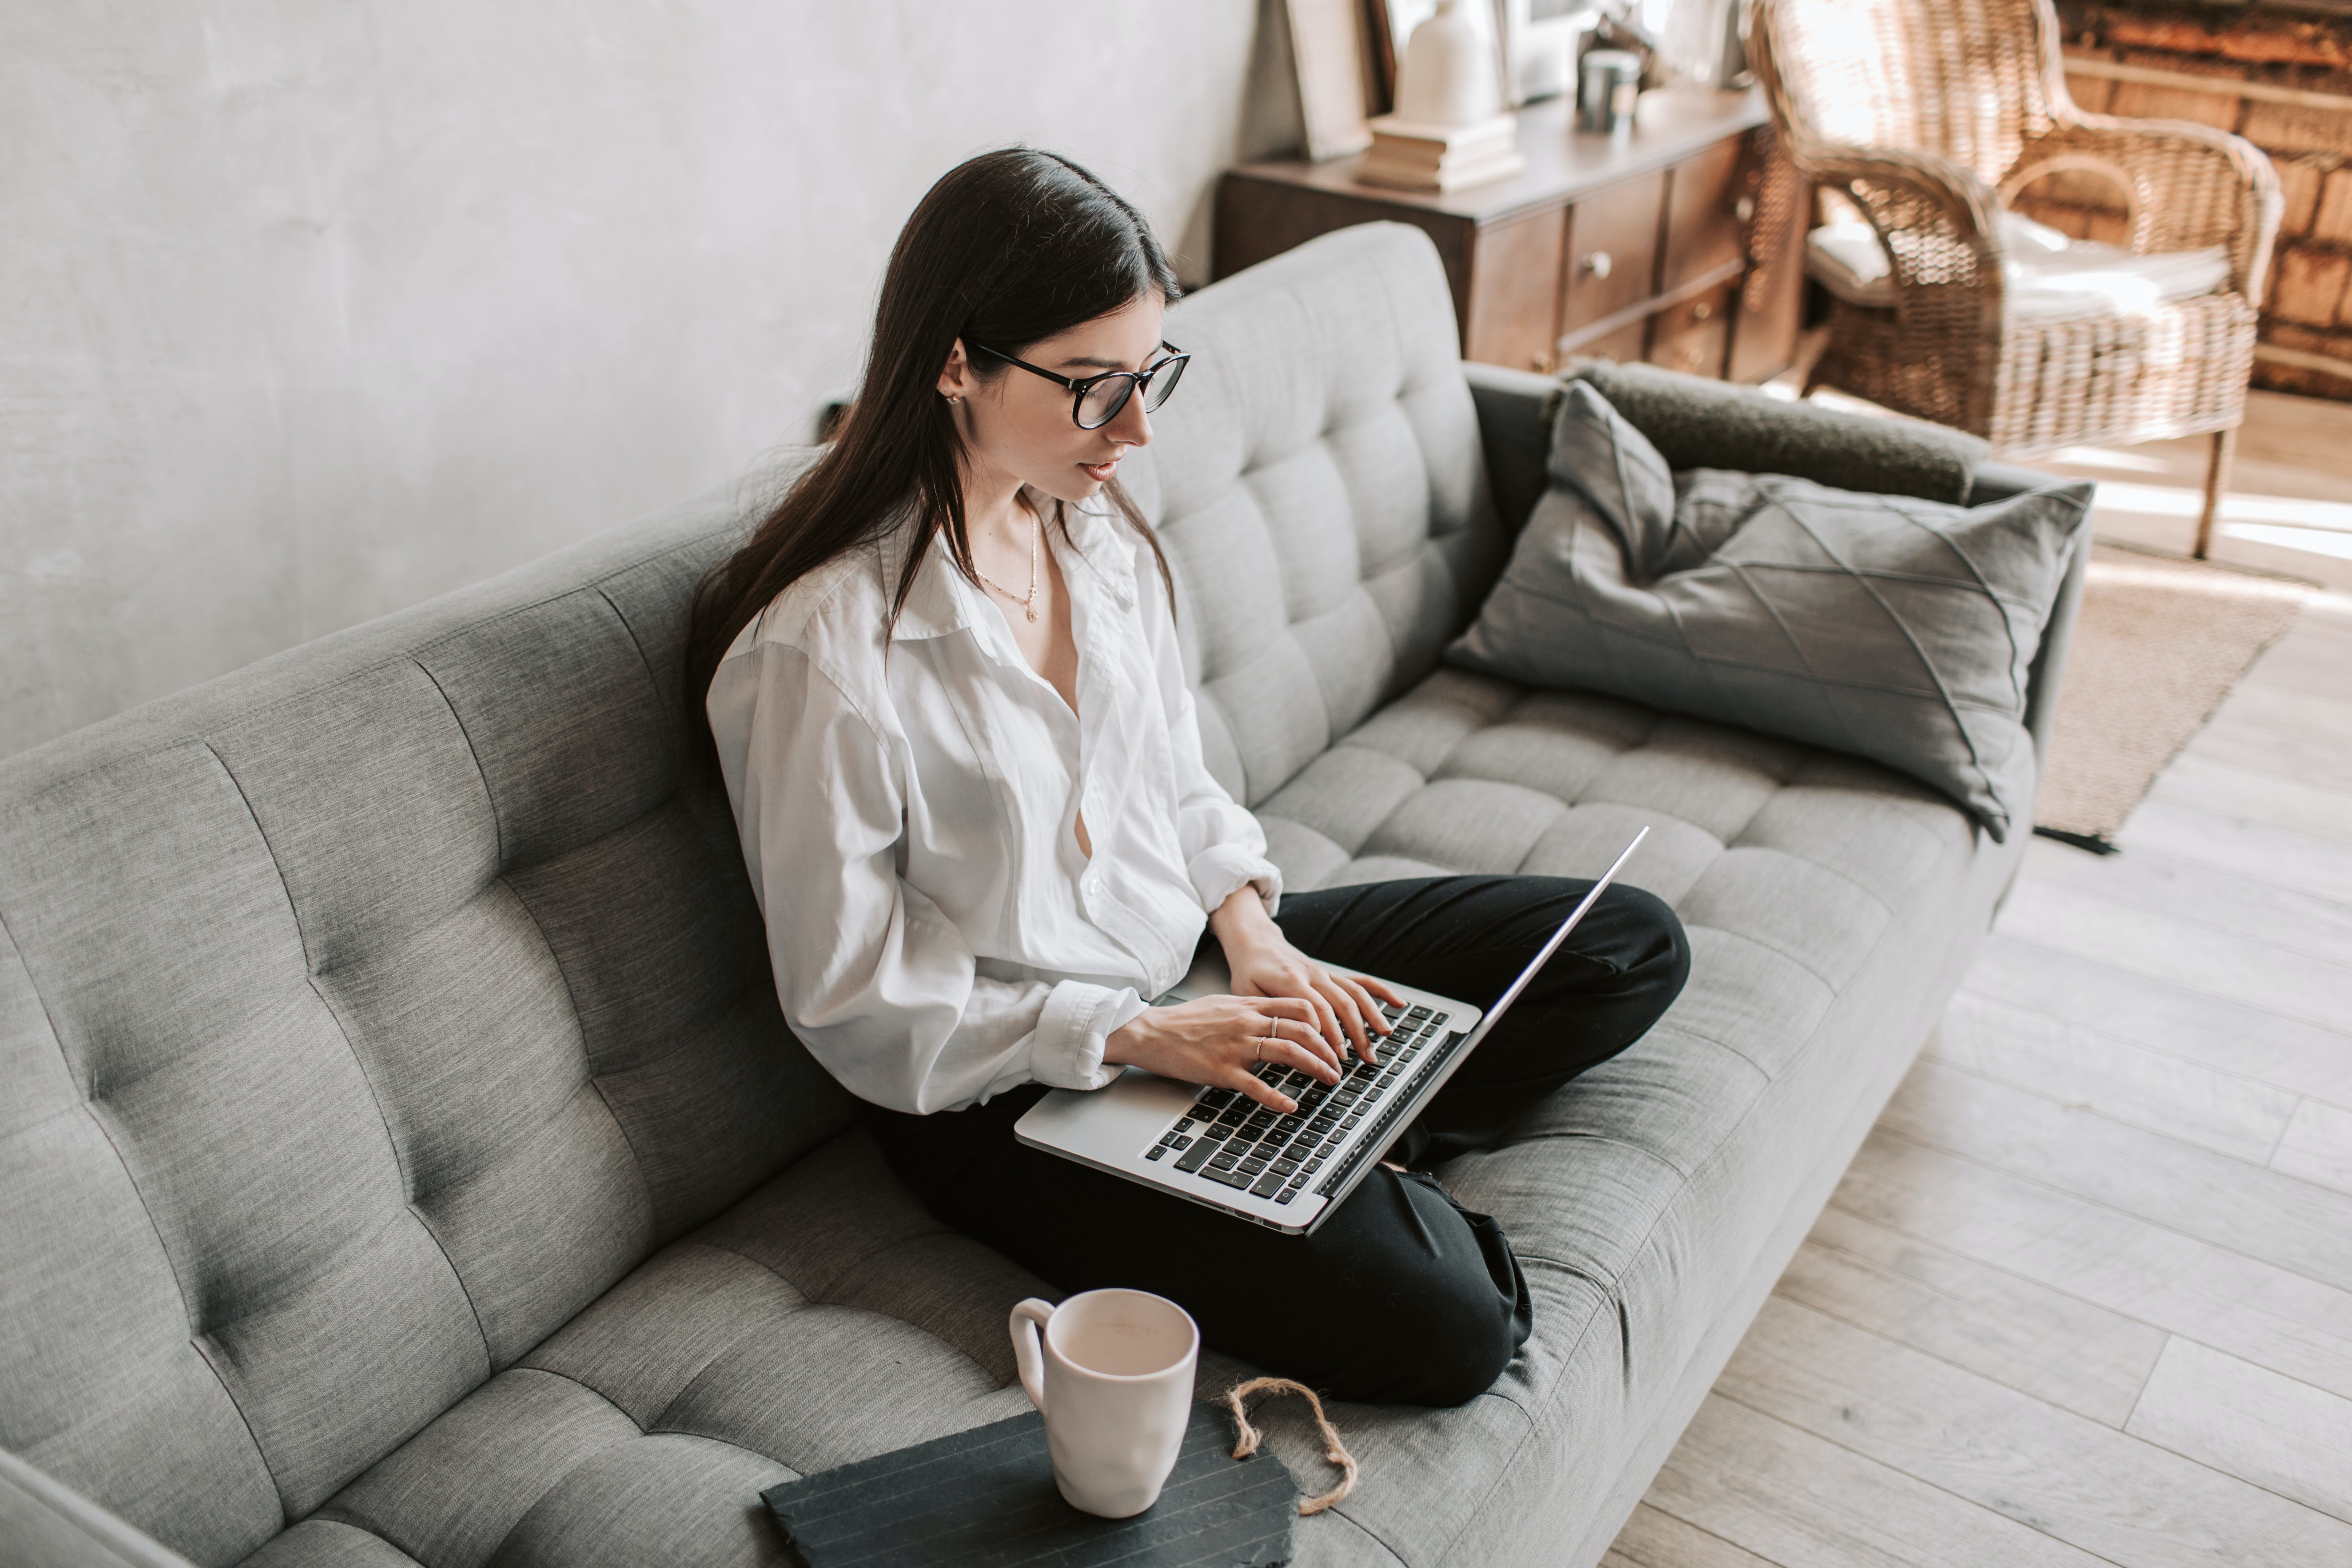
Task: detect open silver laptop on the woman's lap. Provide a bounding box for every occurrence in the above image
[1014,827,1649,1234]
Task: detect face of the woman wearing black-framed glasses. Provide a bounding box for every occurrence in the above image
[938,294,1167,501]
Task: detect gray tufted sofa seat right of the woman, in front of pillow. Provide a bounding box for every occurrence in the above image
[1258,670,2016,1566]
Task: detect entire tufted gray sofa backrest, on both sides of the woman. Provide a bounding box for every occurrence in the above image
[0,215,1500,1563]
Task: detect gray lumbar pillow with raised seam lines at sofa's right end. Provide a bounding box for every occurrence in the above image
[1447,383,2091,839]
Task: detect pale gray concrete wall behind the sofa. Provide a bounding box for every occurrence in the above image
[0,0,1296,755]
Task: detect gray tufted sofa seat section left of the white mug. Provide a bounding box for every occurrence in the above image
[249,1131,1237,1568]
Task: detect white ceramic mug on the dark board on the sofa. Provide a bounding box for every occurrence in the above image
[1011,1290,1200,1519]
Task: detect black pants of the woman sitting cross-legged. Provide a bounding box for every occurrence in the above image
[868,877,1691,1406]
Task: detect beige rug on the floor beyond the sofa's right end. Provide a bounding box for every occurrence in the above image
[2034,545,2317,849]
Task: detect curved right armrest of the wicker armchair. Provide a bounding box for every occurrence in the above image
[2002,111,2286,306]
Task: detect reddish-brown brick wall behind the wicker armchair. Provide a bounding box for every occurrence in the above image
[2018,0,2352,400]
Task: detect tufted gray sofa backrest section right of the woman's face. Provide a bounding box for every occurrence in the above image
[1127,223,1508,806]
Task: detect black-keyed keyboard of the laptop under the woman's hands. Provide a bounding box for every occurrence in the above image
[1143,1001,1449,1204]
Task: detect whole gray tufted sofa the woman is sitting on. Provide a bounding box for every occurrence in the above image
[0,226,2072,1568]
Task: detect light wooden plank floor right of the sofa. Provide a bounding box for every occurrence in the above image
[1604,395,2352,1568]
